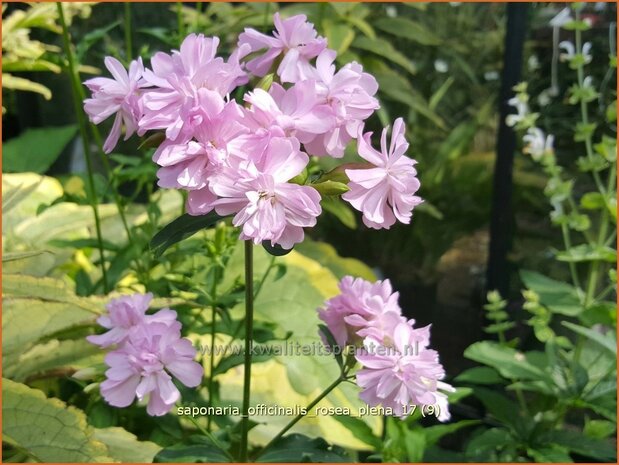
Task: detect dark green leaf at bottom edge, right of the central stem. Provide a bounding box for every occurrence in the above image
[256,434,350,463]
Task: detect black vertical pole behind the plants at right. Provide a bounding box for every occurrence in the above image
[486,2,529,295]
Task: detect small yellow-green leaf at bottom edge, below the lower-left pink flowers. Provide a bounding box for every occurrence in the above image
[94,427,161,463]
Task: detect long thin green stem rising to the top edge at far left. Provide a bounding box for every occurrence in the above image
[56,2,110,294]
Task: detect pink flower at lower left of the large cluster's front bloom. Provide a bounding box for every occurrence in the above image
[153,99,248,215]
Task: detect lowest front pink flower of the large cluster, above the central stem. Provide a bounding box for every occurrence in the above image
[211,137,321,249]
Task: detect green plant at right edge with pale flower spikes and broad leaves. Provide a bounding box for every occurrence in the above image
[456,6,617,462]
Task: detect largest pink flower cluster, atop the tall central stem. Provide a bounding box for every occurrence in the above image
[84,13,421,249]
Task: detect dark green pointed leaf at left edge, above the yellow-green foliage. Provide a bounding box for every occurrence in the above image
[2,124,77,173]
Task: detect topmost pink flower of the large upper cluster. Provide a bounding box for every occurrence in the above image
[239,13,327,82]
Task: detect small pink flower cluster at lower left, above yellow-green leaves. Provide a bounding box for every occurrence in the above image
[87,293,203,416]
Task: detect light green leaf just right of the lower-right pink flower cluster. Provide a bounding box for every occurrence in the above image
[464,341,547,380]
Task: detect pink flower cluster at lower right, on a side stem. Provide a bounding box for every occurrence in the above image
[318,276,454,421]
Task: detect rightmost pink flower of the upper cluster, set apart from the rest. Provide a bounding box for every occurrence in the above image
[342,118,422,229]
